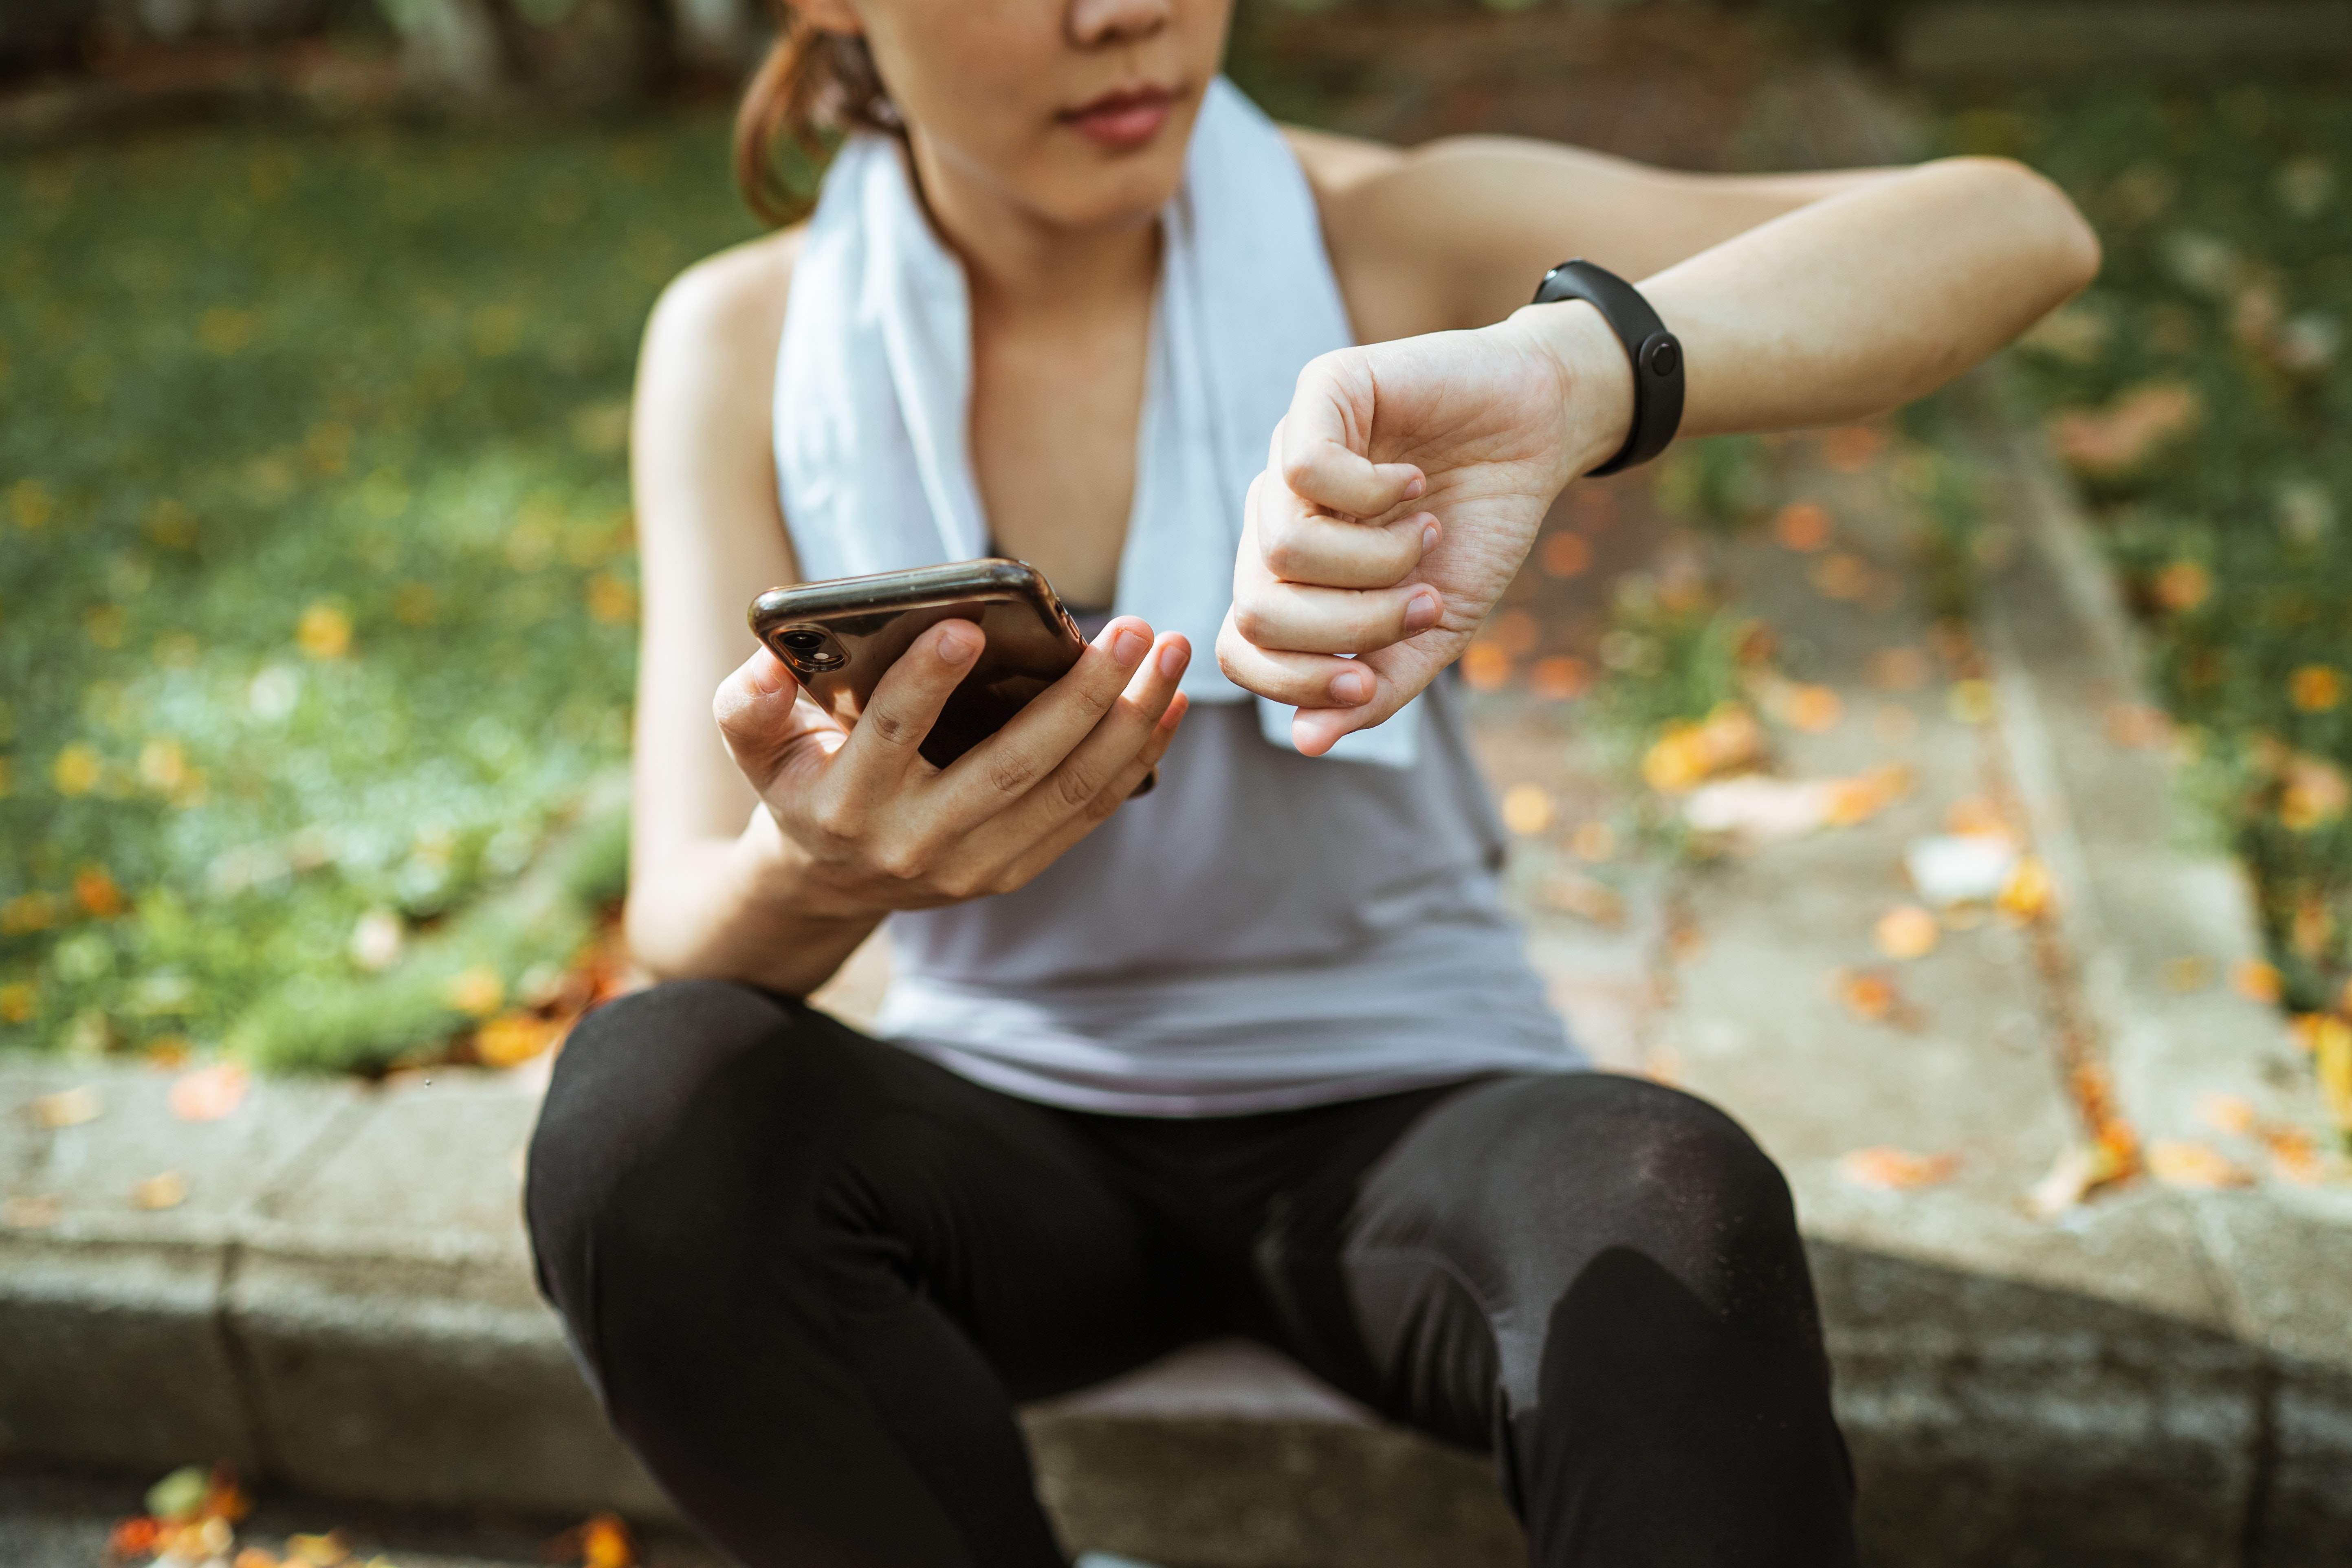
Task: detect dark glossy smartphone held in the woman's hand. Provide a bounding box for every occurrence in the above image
[750,559,1157,794]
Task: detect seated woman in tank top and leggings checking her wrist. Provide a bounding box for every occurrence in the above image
[529,0,2098,1568]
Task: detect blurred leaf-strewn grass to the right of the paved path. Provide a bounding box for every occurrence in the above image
[1945,82,2352,1009]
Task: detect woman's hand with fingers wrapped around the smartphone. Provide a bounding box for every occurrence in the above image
[713,616,1193,919]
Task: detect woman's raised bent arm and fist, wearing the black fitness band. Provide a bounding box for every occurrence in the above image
[1218,143,2098,752]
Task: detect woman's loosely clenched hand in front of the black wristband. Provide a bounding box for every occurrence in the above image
[1216,306,1632,757]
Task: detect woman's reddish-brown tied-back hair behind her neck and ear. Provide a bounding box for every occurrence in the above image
[736,0,901,226]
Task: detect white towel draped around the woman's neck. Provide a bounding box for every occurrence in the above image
[776,77,1421,766]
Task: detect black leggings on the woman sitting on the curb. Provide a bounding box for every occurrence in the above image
[527,983,1853,1568]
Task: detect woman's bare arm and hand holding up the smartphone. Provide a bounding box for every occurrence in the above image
[628,231,1190,994]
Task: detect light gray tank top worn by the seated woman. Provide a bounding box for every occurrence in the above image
[877,675,1585,1117]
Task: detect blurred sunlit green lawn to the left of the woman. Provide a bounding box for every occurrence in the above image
[0,115,750,1065]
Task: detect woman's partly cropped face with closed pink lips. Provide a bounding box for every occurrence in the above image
[804,0,1232,228]
